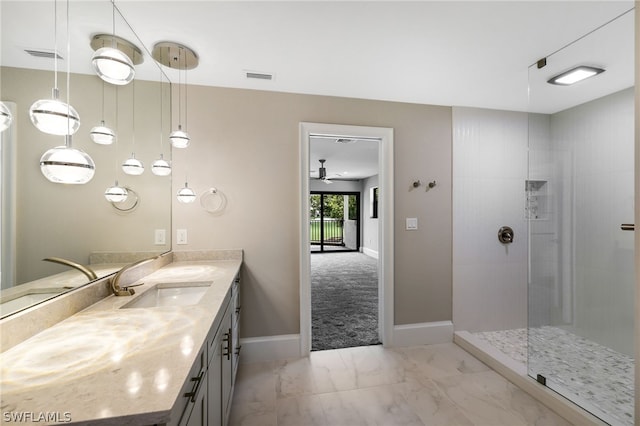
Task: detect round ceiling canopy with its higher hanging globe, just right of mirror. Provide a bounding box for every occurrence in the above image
[151,41,198,148]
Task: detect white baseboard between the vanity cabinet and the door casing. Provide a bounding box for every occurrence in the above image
[240,334,301,363]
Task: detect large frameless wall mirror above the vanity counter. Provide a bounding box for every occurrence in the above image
[0,0,171,316]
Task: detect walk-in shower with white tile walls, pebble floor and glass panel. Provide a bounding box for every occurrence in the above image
[454,11,635,425]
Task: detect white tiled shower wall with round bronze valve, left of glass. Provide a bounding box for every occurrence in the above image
[453,108,528,331]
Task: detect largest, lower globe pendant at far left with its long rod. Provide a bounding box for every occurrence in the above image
[40,0,96,184]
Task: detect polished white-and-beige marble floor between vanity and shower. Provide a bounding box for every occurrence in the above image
[230,343,569,426]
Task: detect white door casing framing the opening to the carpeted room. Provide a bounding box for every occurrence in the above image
[300,123,393,356]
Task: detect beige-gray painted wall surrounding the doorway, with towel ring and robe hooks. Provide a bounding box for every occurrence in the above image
[173,86,451,337]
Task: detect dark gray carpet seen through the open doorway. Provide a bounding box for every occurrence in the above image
[311,252,380,351]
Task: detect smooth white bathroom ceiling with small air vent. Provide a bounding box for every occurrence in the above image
[0,0,634,180]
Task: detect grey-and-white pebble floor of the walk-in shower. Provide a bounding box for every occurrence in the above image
[474,326,634,425]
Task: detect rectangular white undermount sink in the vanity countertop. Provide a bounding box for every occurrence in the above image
[121,281,213,309]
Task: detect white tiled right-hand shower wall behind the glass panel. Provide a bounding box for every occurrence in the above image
[551,88,634,356]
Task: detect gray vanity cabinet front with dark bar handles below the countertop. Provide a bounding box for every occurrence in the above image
[171,276,240,426]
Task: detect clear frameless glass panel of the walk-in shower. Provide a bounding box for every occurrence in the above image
[522,8,635,425]
